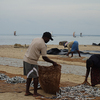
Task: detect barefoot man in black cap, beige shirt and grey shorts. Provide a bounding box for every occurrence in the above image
[23,32,57,97]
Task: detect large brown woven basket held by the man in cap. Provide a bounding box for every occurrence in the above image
[39,65,61,94]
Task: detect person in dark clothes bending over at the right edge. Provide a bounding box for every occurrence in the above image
[83,54,100,86]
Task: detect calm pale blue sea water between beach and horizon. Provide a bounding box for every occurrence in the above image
[0,34,100,45]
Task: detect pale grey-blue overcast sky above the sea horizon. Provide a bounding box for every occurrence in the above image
[0,0,100,35]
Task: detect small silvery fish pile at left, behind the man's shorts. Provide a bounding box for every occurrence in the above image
[0,73,26,84]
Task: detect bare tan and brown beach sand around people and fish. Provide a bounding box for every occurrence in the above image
[0,45,100,100]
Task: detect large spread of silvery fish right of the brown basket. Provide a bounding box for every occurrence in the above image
[44,84,100,100]
